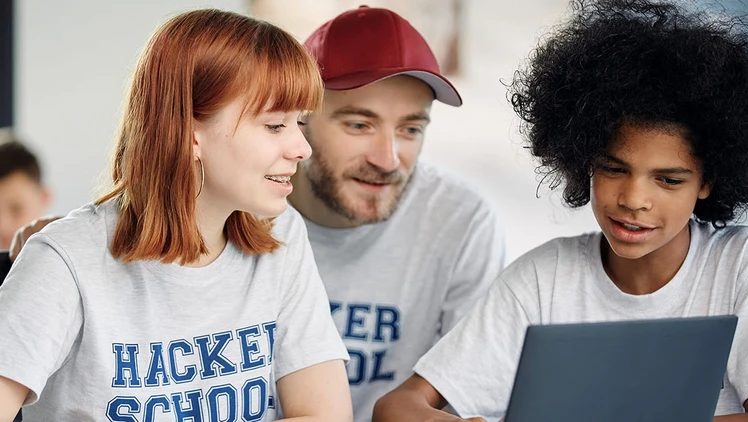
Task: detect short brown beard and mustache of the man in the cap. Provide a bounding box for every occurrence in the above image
[304,149,411,225]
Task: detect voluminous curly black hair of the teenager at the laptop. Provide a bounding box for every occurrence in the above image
[508,0,748,227]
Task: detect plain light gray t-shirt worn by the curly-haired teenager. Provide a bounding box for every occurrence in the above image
[415,221,748,421]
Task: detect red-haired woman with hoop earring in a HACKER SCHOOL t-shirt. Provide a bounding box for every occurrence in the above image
[0,10,352,422]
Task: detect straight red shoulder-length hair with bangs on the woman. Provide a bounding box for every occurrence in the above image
[96,10,323,263]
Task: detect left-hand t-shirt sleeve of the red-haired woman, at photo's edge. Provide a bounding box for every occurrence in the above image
[0,234,83,404]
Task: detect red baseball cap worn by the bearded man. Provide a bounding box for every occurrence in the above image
[304,6,462,107]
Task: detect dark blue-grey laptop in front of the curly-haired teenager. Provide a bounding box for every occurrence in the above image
[506,315,738,422]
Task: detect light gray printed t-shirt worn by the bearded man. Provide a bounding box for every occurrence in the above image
[306,162,505,422]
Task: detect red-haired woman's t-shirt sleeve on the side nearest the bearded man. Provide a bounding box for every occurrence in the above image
[273,213,349,379]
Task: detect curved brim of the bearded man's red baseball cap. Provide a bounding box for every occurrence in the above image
[325,69,462,107]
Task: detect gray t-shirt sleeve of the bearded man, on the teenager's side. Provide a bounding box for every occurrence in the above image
[439,205,506,336]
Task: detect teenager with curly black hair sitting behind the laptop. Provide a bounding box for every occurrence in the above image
[374,0,748,422]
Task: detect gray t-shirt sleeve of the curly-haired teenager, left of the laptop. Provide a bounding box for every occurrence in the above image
[414,277,530,421]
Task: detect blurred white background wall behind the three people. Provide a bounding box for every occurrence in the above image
[14,0,596,259]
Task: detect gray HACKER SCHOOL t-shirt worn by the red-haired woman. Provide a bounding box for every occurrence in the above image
[0,202,347,422]
